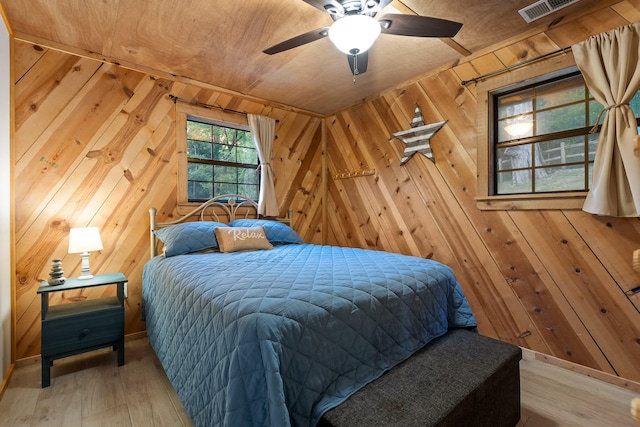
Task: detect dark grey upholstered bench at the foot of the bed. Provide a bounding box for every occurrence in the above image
[318,330,522,427]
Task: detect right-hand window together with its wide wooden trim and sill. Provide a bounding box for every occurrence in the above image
[476,55,640,210]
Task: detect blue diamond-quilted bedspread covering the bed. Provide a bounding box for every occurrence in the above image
[143,244,476,427]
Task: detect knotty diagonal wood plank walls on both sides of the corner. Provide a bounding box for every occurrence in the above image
[13,0,640,388]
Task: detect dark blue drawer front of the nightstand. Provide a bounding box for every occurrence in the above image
[42,307,124,357]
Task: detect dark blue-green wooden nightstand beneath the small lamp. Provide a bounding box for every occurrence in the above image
[38,273,127,388]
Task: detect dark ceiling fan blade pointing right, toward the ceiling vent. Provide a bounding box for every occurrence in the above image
[378,13,462,38]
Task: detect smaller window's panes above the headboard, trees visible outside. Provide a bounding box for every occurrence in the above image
[187,116,260,202]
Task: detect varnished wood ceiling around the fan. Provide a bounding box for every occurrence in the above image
[0,0,598,115]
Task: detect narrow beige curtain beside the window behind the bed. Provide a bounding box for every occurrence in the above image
[247,114,279,216]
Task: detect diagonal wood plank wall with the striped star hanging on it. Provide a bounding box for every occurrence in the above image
[327,1,640,381]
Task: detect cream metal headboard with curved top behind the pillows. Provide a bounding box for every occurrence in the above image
[149,194,293,258]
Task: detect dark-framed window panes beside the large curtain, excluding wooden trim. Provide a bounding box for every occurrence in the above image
[492,71,603,195]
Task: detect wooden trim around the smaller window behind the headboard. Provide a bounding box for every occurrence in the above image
[176,103,260,215]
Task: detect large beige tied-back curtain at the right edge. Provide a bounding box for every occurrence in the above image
[571,23,640,217]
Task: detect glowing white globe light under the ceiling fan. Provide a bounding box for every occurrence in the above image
[329,15,380,55]
